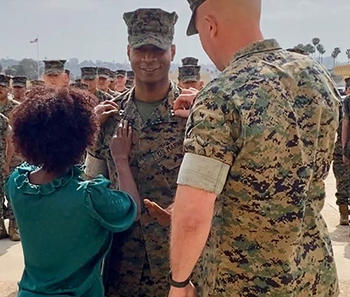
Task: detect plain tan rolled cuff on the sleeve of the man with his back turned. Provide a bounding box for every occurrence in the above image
[177,153,230,195]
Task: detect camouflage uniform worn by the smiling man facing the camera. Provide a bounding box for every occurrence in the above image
[89,83,186,297]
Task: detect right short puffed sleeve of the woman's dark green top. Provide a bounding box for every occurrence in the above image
[79,176,137,232]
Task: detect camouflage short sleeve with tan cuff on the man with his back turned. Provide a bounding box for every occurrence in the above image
[177,81,241,194]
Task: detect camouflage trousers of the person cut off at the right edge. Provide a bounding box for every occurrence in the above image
[333,143,350,205]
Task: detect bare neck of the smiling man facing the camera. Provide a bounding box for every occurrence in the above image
[135,76,170,102]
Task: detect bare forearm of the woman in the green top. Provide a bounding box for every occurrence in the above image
[115,160,141,219]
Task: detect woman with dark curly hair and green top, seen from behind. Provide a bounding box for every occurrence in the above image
[6,88,140,297]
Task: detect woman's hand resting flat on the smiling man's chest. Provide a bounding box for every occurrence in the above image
[109,120,132,164]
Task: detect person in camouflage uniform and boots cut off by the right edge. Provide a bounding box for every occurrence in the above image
[333,81,350,225]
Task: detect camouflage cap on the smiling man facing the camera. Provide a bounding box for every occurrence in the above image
[124,8,178,50]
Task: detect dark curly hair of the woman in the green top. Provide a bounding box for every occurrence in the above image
[11,87,98,173]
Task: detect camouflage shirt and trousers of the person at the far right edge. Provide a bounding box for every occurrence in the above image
[333,96,350,205]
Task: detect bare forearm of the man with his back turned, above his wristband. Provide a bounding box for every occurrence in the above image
[170,186,215,282]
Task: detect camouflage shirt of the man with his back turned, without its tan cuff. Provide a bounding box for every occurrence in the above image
[184,40,339,297]
